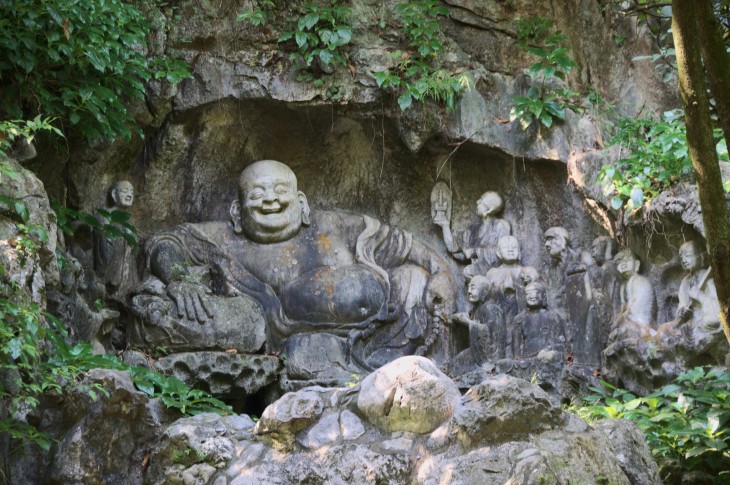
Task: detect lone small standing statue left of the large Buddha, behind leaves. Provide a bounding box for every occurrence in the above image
[94,180,138,303]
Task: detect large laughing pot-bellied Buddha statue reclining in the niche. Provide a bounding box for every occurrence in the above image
[135,160,456,383]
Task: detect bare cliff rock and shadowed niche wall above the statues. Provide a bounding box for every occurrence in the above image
[48,1,668,241]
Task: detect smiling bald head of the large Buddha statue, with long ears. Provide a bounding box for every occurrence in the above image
[230,160,309,243]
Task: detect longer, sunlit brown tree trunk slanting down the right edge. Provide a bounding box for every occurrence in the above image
[672,0,730,342]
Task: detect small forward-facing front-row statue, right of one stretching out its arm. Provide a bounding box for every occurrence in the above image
[512,283,565,358]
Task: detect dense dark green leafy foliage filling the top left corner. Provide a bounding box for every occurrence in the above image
[0,0,190,144]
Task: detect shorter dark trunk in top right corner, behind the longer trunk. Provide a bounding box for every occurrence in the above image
[694,0,730,142]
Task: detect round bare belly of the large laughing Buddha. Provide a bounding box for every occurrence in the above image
[279,264,386,323]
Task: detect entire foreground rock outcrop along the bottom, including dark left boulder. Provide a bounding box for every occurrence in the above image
[12,357,660,485]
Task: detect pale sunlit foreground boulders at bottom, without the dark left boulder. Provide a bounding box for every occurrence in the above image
[146,357,660,485]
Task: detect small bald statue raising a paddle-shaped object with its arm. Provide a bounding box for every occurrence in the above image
[434,192,512,280]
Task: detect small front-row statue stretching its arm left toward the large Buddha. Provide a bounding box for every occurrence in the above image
[450,275,508,366]
